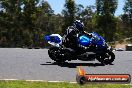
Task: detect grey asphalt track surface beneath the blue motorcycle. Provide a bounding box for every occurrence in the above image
[0,48,132,82]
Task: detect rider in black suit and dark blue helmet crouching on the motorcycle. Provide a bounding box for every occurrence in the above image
[62,20,92,50]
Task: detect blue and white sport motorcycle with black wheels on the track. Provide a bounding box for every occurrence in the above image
[45,32,115,65]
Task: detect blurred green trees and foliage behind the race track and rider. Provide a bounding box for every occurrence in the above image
[0,0,132,47]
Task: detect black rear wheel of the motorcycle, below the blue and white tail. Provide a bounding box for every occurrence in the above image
[48,47,66,63]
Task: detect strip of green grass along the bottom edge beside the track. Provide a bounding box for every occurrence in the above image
[0,81,132,88]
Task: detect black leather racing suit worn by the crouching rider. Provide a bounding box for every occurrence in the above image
[62,26,92,50]
